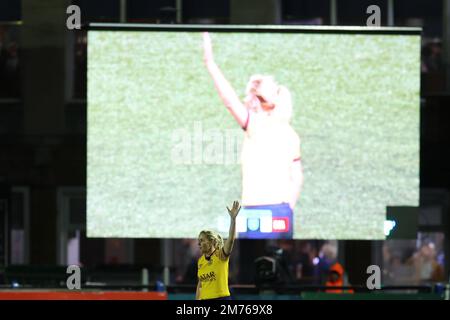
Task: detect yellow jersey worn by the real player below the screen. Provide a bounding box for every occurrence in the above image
[197,248,230,300]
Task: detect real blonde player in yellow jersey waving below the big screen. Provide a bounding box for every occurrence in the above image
[195,201,241,300]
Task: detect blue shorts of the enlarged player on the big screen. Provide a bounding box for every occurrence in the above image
[238,203,294,239]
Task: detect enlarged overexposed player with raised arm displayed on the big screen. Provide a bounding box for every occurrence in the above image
[203,32,303,239]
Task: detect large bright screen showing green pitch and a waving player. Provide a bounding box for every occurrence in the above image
[87,26,420,239]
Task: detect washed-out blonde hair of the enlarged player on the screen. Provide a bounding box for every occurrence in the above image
[244,74,292,122]
